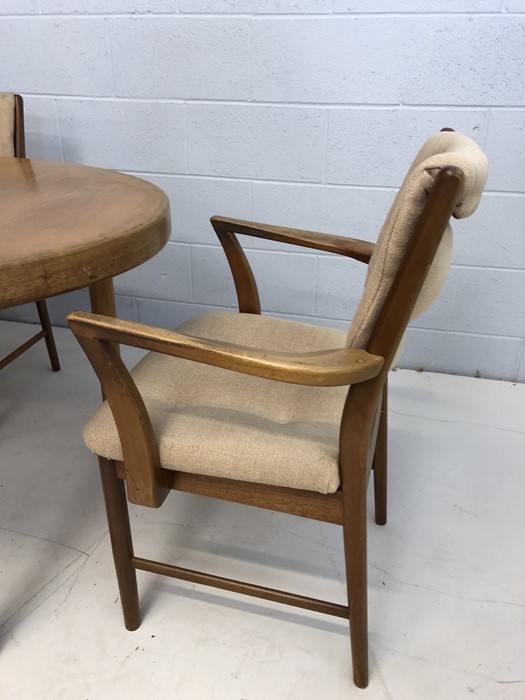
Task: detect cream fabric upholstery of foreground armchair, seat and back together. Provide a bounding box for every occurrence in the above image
[84,132,487,493]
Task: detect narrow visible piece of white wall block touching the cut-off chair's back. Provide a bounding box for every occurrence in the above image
[24,97,62,161]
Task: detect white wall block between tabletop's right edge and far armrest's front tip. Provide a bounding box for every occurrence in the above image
[141,175,251,245]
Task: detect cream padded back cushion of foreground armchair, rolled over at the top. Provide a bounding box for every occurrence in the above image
[347,131,487,358]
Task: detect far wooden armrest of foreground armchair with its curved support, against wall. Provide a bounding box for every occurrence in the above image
[210,216,374,314]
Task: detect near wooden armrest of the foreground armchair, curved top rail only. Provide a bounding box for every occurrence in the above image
[67,312,384,386]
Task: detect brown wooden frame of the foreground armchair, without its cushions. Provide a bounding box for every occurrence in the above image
[68,161,464,688]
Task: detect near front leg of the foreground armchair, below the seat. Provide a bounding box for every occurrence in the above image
[98,457,140,630]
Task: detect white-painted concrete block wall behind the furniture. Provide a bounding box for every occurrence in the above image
[0,0,525,381]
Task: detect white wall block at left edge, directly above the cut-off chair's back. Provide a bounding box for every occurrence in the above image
[0,16,113,96]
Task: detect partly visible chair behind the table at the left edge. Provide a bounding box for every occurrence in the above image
[0,93,60,372]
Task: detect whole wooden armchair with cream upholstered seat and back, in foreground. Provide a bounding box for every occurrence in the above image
[68,131,486,687]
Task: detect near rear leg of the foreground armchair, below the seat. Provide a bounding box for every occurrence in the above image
[343,476,368,688]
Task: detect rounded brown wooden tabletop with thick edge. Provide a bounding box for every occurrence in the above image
[0,158,170,308]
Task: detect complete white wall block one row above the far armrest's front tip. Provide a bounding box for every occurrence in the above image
[187,104,327,182]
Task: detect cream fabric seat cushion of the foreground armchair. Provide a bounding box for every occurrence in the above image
[84,312,348,493]
